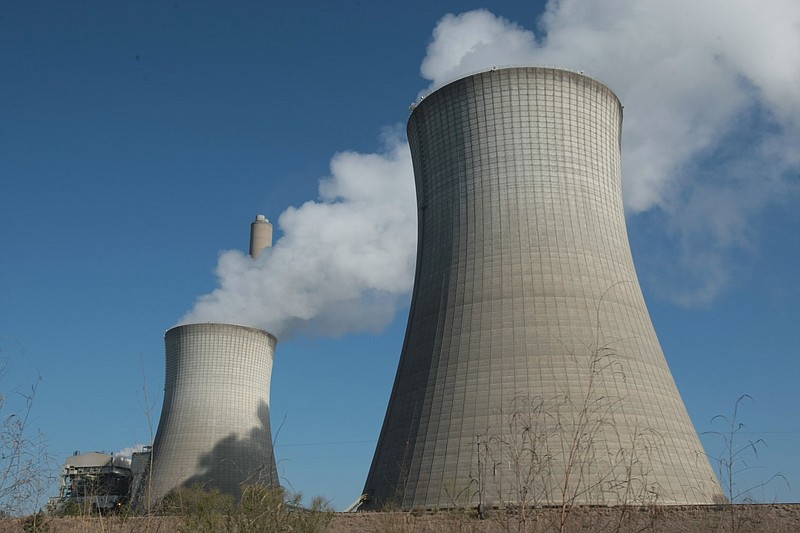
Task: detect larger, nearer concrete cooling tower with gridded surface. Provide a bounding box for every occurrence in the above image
[364,67,720,509]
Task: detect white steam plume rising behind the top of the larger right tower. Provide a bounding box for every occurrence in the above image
[421,0,800,304]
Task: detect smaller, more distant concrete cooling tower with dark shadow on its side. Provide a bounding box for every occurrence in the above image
[149,324,278,502]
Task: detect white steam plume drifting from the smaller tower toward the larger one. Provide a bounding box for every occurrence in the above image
[182,130,417,338]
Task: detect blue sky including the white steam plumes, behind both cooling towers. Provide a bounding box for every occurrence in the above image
[0,1,800,508]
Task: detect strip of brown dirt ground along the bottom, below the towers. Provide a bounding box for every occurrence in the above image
[0,504,800,533]
